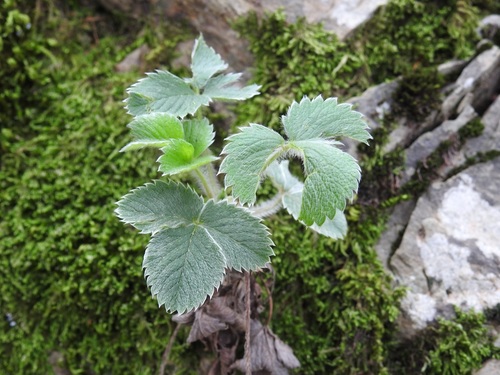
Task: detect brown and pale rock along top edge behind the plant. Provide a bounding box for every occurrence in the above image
[94,0,388,71]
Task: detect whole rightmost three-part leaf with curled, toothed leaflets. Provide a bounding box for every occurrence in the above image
[221,96,370,226]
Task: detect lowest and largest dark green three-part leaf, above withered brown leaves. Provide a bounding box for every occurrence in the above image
[116,181,273,313]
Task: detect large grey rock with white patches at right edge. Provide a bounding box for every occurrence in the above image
[390,158,500,335]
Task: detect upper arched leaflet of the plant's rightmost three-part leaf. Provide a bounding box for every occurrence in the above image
[282,96,371,143]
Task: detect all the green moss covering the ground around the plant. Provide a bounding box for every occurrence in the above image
[0,0,495,374]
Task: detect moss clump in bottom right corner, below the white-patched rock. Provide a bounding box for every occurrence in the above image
[391,308,499,375]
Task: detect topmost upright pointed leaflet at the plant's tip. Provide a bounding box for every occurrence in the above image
[191,35,227,89]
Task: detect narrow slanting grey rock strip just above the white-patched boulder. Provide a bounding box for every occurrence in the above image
[400,106,477,185]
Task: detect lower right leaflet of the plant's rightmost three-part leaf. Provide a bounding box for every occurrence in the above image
[294,139,361,225]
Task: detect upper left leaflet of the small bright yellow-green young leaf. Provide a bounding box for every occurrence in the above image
[121,113,184,151]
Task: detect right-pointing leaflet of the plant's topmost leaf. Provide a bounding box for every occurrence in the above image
[203,73,260,100]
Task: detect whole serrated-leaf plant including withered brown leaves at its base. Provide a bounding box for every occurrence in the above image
[116,36,370,373]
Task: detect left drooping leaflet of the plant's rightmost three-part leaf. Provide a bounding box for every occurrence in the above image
[220,124,285,204]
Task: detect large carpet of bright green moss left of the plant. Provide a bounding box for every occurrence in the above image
[0,2,197,374]
